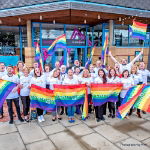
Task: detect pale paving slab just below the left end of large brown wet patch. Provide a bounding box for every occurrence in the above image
[94,125,129,143]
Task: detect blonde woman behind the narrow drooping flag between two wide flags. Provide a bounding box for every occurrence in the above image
[79,69,93,113]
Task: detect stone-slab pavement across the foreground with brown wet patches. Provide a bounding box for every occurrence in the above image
[0,114,150,150]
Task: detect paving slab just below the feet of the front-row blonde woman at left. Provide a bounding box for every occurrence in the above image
[17,123,47,144]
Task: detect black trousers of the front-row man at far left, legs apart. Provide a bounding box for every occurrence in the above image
[6,98,21,120]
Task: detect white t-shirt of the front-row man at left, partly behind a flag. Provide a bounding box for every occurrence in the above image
[2,75,19,99]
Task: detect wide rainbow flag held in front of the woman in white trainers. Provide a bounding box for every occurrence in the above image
[30,84,56,111]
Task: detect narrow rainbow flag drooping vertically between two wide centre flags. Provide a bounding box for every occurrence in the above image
[82,88,89,120]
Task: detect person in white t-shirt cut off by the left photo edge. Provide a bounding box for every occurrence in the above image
[0,62,7,119]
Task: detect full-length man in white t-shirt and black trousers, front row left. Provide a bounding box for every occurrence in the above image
[2,66,24,124]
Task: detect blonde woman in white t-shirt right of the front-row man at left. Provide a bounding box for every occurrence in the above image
[20,67,31,122]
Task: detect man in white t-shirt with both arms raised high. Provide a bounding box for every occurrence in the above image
[109,50,143,73]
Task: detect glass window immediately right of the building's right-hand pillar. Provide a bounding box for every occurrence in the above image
[114,25,128,46]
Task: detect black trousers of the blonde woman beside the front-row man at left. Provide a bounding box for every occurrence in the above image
[21,96,30,116]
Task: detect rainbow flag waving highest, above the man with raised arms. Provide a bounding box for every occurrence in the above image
[130,20,147,40]
